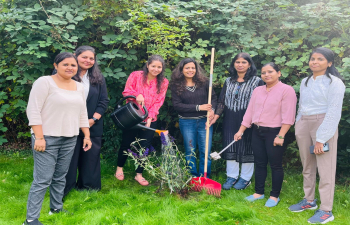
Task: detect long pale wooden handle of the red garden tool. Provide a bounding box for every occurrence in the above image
[204,48,215,178]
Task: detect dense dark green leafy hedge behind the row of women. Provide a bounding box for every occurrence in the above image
[0,0,350,171]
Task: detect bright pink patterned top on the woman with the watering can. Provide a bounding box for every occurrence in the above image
[123,71,169,122]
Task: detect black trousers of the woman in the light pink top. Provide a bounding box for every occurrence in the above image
[252,125,286,198]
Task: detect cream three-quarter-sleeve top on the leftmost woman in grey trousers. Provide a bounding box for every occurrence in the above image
[26,76,89,137]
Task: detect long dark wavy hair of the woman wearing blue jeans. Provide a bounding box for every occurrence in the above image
[170,58,208,95]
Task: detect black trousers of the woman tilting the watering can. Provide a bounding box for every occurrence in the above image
[117,121,157,173]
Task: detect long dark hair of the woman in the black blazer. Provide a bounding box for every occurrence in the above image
[73,45,103,85]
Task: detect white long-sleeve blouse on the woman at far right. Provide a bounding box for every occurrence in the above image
[296,74,345,143]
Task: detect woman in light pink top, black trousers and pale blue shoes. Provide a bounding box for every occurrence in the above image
[234,63,297,207]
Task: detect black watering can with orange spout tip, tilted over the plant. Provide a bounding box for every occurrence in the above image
[111,95,165,135]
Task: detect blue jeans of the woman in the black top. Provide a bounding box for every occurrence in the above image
[179,118,213,177]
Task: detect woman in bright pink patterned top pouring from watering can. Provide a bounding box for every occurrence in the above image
[115,55,169,186]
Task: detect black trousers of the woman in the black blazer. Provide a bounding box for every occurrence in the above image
[64,136,102,196]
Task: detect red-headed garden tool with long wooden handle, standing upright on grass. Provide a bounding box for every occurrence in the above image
[190,48,221,197]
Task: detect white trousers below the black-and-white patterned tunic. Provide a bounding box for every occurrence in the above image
[226,160,254,181]
